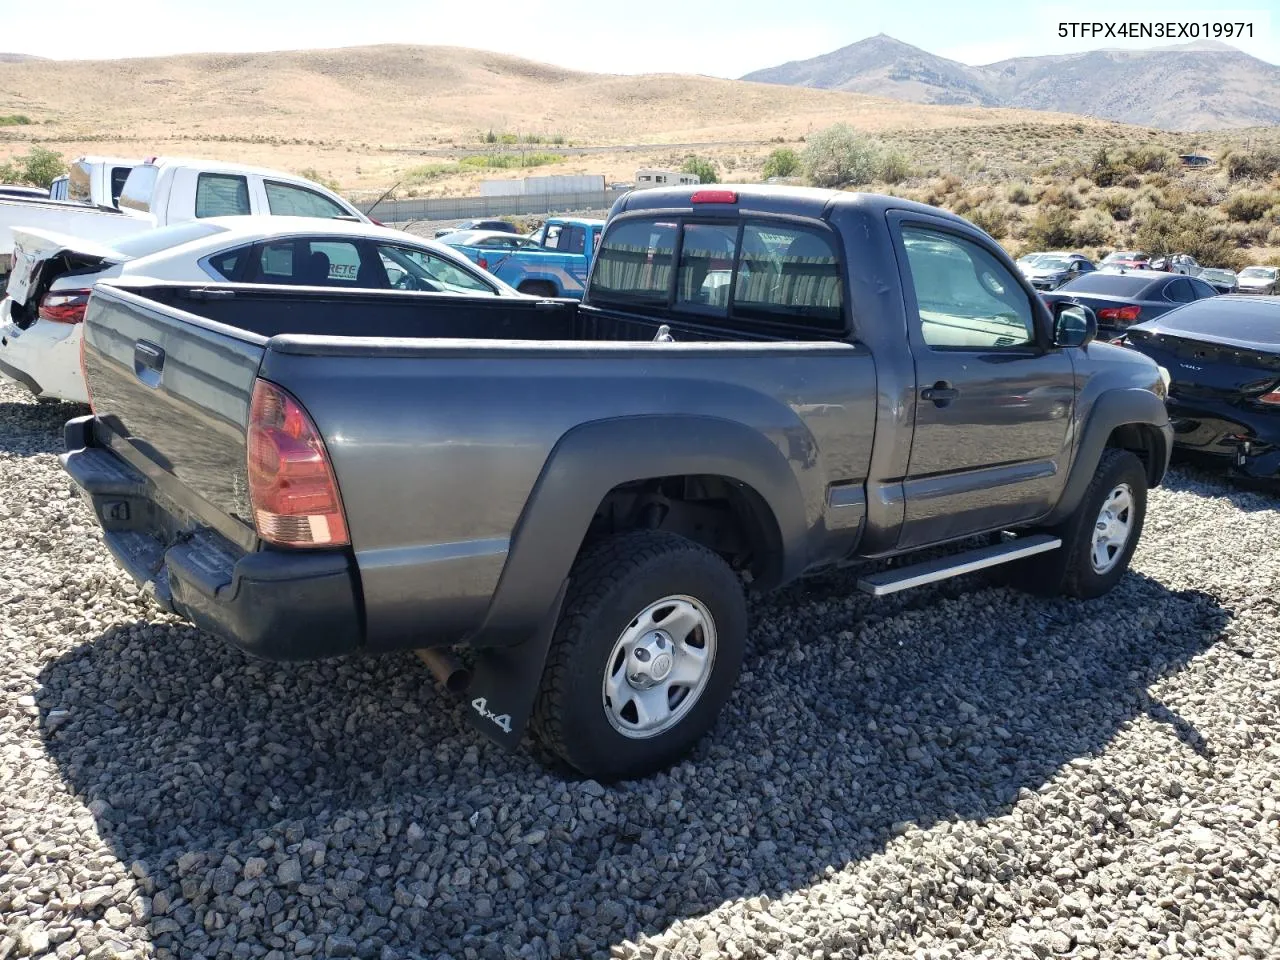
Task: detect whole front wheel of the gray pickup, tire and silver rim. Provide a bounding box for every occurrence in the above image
[1005,447,1147,599]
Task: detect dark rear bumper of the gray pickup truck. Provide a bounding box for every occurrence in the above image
[59,417,364,660]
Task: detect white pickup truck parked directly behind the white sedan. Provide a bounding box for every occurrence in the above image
[0,157,370,284]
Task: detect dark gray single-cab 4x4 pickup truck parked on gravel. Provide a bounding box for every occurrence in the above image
[63,186,1172,780]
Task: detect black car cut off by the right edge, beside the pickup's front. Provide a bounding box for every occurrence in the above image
[1123,294,1280,480]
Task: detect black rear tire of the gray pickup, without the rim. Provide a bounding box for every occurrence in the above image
[531,530,748,782]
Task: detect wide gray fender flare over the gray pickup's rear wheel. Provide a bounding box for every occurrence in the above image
[468,415,809,648]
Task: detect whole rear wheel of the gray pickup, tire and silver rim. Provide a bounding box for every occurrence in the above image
[532,531,746,782]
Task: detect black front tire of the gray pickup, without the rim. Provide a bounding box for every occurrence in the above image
[1004,447,1147,599]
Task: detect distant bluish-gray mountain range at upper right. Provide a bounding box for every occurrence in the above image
[742,33,1280,131]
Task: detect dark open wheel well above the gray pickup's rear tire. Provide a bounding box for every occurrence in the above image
[582,474,782,586]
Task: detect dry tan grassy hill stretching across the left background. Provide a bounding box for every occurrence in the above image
[0,45,1105,188]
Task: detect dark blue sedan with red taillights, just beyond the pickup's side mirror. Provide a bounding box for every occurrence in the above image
[1041,270,1217,337]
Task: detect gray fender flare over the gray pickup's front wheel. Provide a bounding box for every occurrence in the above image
[1043,388,1172,525]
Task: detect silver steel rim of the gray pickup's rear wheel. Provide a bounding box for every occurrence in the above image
[600,595,716,740]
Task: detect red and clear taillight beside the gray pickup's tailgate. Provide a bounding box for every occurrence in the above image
[248,380,349,547]
